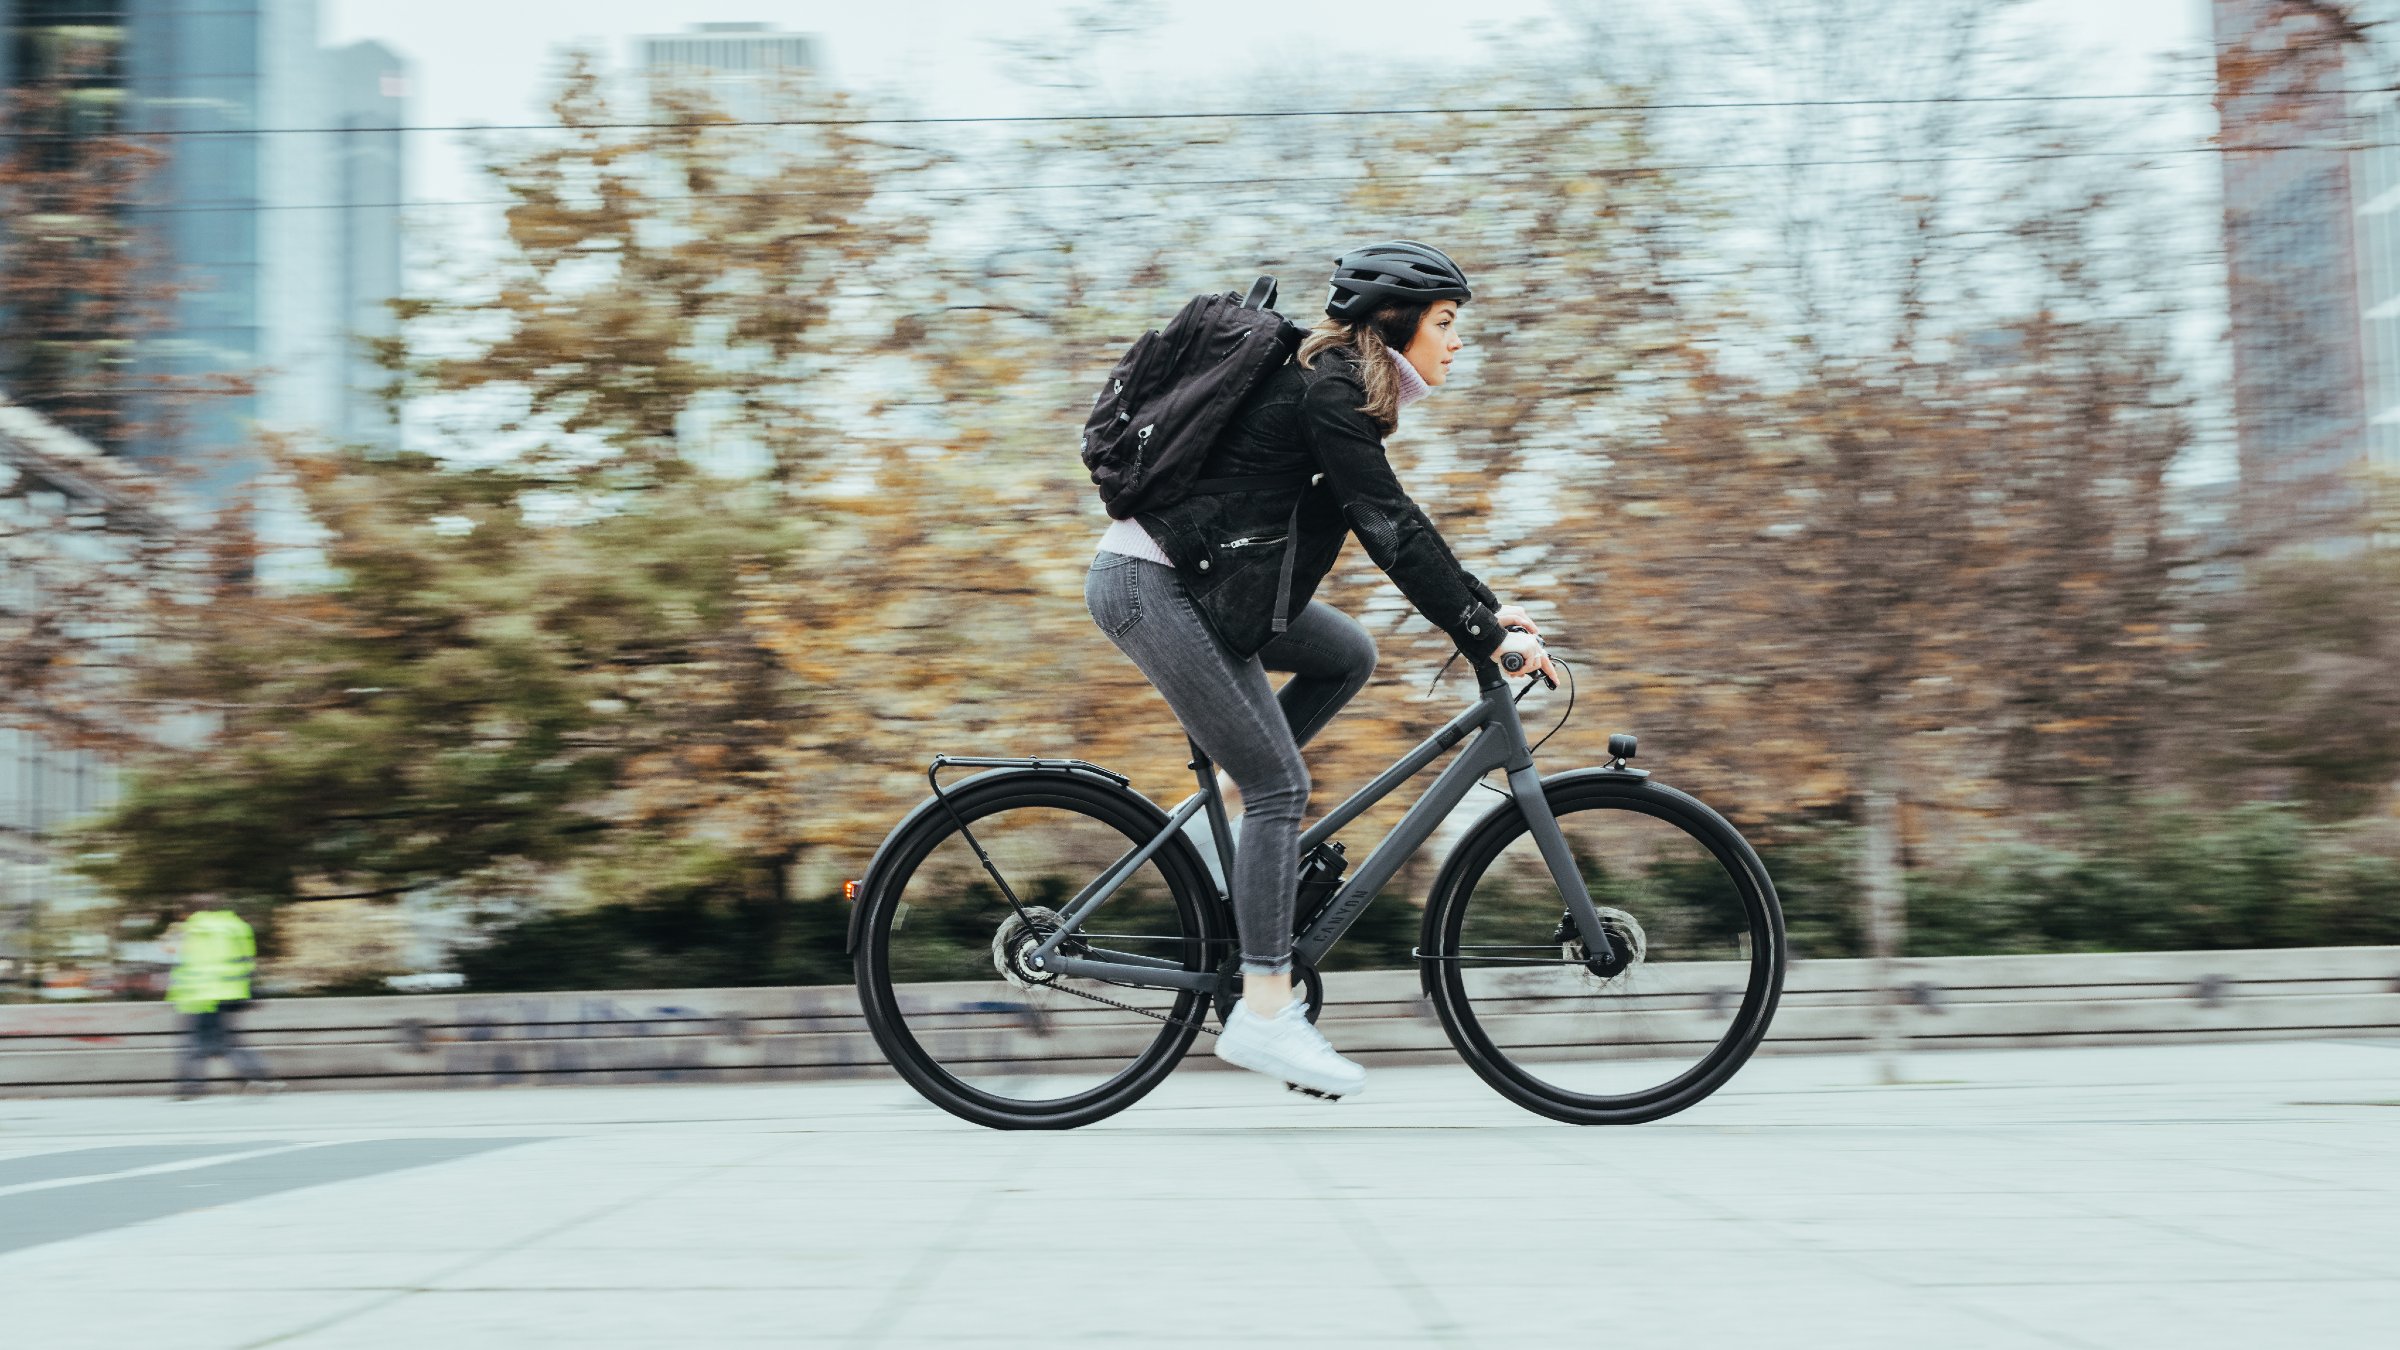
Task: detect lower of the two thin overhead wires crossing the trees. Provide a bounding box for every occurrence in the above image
[108,142,2361,216]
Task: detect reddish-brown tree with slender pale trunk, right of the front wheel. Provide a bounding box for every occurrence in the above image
[1555,0,2189,1061]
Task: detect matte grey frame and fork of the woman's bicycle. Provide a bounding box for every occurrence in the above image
[1027,663,1613,992]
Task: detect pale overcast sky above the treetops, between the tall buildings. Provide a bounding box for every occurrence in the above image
[322,0,2225,476]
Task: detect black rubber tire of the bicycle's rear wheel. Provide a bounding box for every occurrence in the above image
[852,769,1224,1129]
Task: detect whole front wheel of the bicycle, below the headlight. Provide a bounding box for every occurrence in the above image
[1421,776,1783,1124]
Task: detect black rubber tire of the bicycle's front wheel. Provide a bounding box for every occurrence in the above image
[1421,771,1788,1124]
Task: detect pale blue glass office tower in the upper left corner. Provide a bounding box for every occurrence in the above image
[0,0,408,468]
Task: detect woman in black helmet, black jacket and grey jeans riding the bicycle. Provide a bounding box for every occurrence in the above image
[1085,240,1550,1095]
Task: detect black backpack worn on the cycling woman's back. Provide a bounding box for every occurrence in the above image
[1082,276,1308,519]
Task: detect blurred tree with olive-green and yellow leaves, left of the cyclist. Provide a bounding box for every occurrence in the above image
[94,58,917,941]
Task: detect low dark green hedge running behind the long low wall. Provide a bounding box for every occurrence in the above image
[403,802,2400,992]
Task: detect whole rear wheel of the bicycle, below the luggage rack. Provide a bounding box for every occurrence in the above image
[854,769,1222,1129]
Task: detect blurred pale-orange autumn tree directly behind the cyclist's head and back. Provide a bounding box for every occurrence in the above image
[768,34,1733,908]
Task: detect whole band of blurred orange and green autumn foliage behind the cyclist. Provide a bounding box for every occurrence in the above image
[18,10,2400,980]
